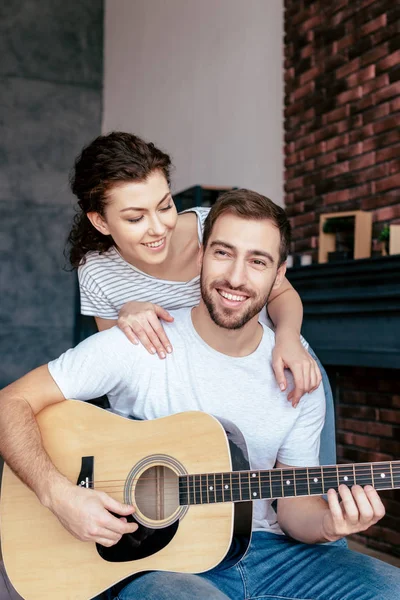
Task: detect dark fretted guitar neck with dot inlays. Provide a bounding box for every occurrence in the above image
[179,461,400,505]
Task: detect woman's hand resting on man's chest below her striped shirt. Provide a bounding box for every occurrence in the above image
[117,301,174,358]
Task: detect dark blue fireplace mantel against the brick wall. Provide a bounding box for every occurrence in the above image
[287,255,400,369]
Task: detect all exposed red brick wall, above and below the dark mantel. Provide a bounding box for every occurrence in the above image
[284,0,400,555]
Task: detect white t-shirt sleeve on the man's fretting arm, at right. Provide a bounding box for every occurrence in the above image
[277,383,325,467]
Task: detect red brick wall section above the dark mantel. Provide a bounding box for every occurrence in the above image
[284,0,400,261]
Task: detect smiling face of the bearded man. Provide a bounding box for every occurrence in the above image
[200,213,286,329]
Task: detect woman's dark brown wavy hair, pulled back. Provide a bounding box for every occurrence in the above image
[68,131,171,268]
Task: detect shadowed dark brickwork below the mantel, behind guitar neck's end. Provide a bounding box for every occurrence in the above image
[329,367,400,556]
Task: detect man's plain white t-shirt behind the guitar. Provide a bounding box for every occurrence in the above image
[48,308,325,533]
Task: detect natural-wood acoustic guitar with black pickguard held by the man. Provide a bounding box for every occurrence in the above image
[0,400,400,600]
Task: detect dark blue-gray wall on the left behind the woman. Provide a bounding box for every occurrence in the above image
[0,0,103,387]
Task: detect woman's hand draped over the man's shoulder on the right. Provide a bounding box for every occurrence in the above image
[272,335,322,408]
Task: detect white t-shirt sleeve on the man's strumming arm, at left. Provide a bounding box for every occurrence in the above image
[48,327,138,400]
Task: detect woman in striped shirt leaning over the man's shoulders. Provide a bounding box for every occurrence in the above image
[69,132,321,406]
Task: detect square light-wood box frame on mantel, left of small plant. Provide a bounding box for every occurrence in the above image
[318,210,372,263]
